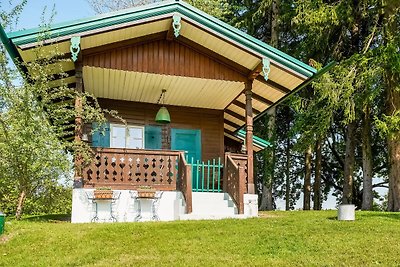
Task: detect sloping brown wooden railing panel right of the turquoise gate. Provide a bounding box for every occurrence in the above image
[223,153,246,214]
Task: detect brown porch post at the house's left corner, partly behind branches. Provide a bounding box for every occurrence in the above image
[74,57,83,188]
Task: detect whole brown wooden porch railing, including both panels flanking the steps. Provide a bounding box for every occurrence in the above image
[83,148,247,214]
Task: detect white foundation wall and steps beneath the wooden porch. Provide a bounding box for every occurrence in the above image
[71,189,258,223]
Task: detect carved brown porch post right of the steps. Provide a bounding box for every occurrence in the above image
[245,80,255,194]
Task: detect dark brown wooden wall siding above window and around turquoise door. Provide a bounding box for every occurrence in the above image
[95,99,224,160]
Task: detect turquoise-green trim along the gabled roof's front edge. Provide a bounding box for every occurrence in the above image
[2,1,317,77]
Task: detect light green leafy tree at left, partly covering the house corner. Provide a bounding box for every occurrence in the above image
[0,1,111,219]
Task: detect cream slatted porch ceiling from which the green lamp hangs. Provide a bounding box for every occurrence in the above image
[83,66,244,110]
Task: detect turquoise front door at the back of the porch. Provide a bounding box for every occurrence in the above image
[171,128,201,162]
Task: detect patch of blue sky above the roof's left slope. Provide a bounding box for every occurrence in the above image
[6,0,96,30]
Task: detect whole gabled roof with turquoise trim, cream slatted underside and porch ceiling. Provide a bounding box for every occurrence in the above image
[0,1,332,147]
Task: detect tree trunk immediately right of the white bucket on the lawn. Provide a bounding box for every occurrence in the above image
[361,105,373,210]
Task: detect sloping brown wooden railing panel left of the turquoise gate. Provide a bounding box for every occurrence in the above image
[178,152,192,213]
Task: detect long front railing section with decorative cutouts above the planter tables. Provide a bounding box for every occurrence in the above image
[83,148,181,191]
